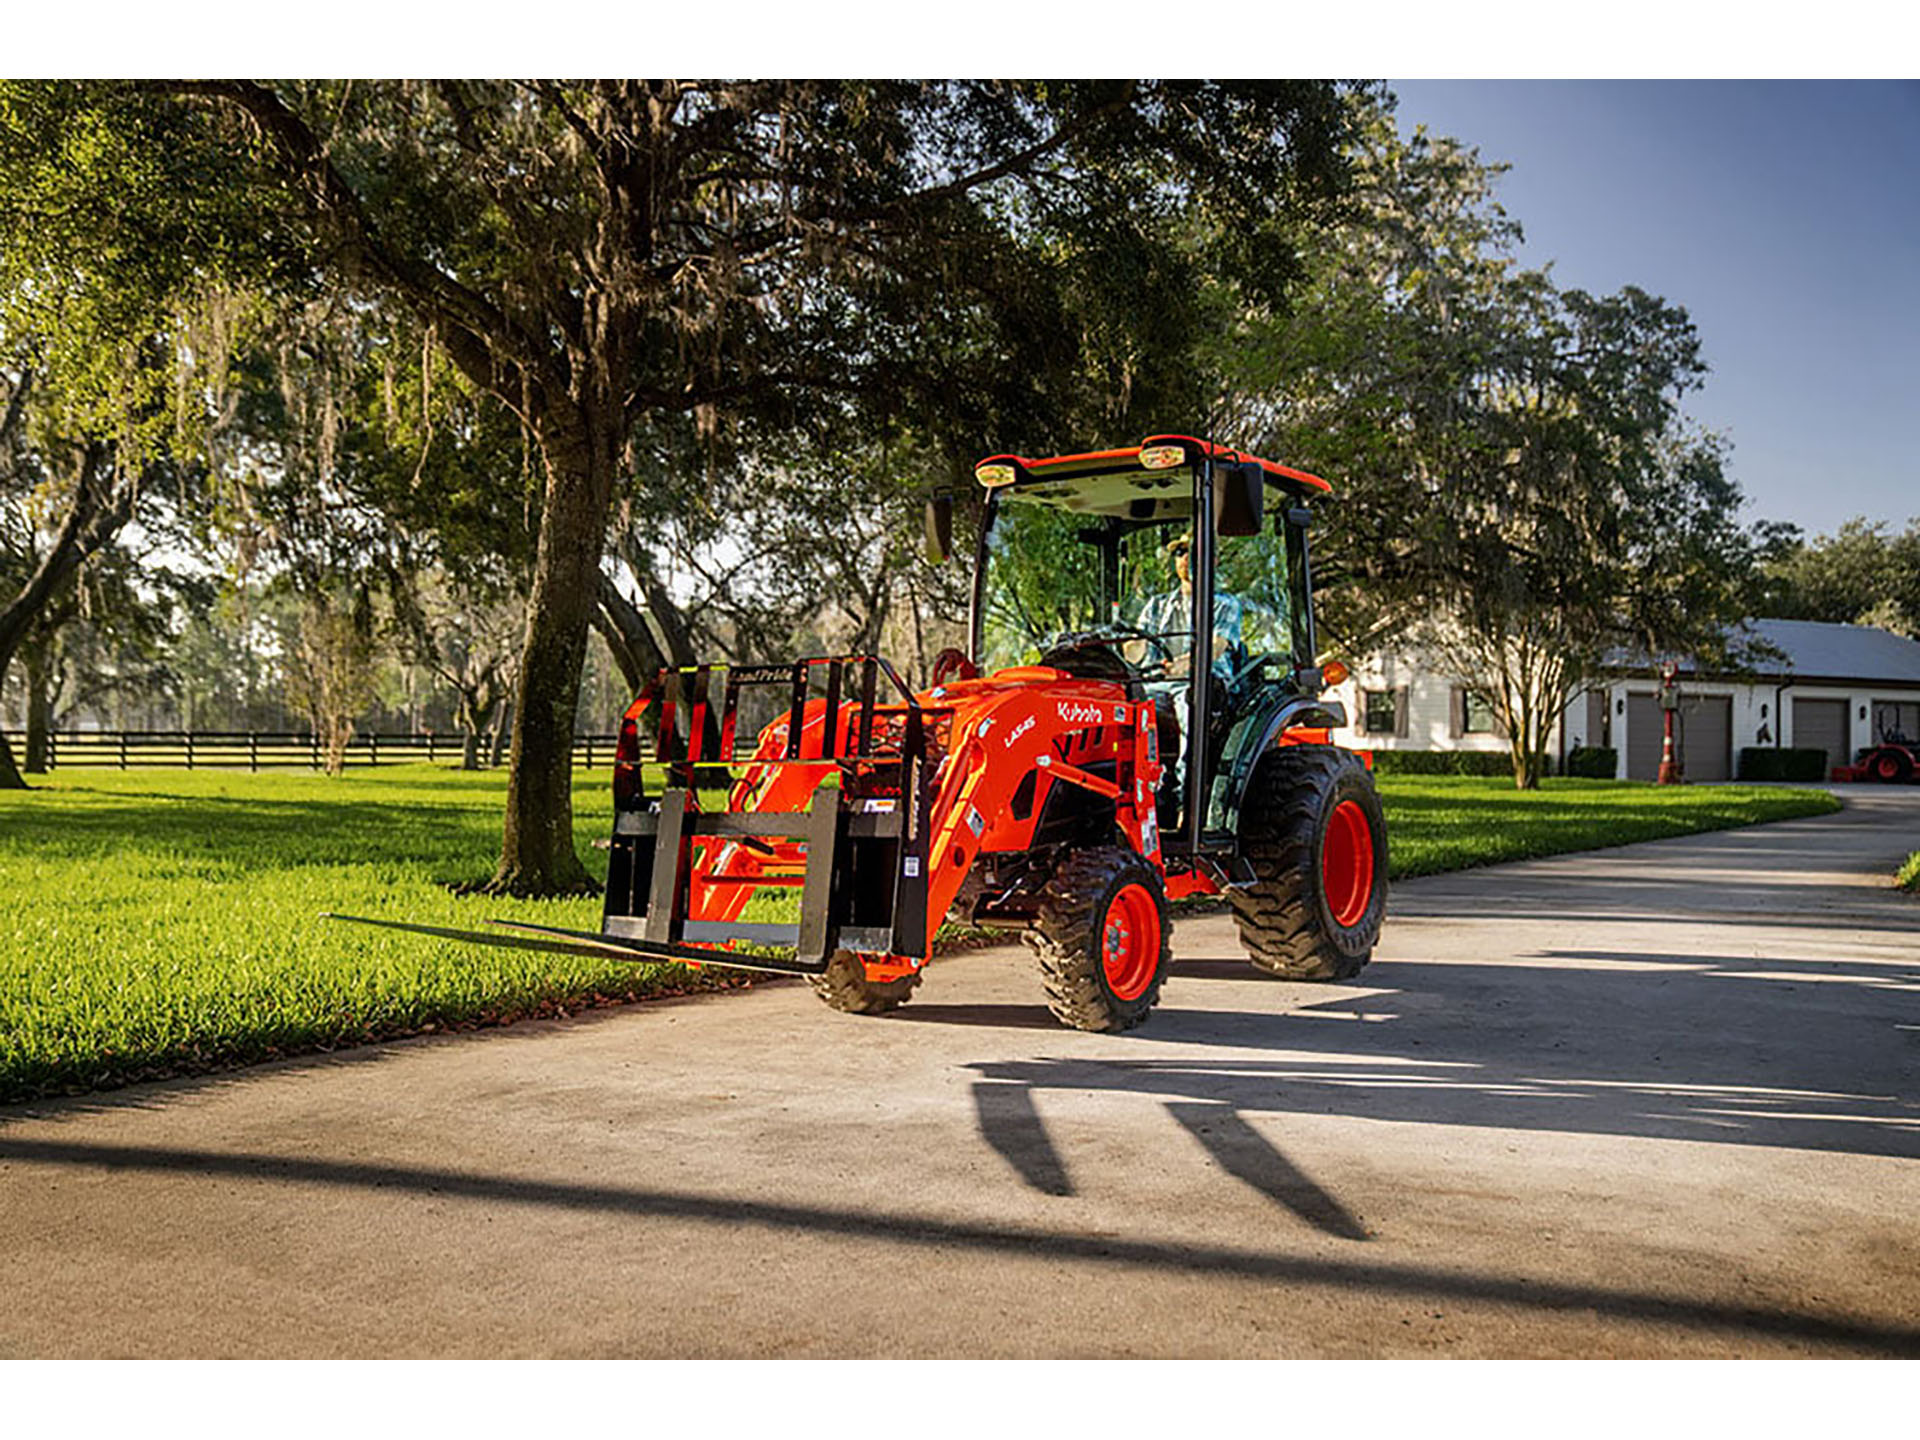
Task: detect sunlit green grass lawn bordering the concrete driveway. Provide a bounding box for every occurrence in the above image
[0,766,1837,1102]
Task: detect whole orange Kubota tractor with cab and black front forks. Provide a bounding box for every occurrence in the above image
[353,436,1386,1031]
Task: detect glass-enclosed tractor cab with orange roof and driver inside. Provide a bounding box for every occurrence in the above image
[972,436,1346,864]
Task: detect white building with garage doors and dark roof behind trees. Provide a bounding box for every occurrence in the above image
[1329,620,1920,781]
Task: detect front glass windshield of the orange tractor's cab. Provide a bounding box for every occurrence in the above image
[979,492,1192,678]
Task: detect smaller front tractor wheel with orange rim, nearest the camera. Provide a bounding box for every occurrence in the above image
[1021,845,1173,1033]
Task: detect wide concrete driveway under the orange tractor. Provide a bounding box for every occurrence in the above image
[0,791,1920,1356]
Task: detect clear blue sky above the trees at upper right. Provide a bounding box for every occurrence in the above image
[1388,81,1920,534]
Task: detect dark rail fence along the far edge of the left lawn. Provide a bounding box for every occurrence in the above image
[0,730,618,770]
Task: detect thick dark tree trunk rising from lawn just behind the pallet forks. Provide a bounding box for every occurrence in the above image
[486,405,624,895]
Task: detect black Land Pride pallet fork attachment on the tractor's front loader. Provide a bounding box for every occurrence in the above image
[324,655,933,975]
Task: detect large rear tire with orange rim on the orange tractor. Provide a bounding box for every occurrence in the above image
[1229,745,1386,979]
